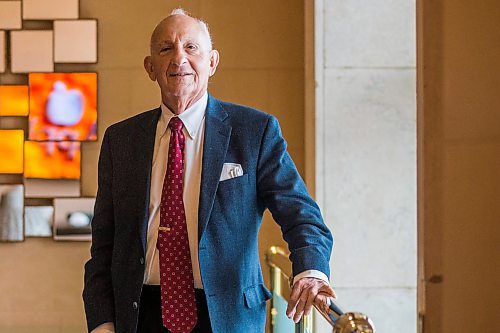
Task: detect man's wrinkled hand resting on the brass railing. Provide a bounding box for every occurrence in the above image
[286,277,337,323]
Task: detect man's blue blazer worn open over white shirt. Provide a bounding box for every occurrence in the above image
[83,96,333,333]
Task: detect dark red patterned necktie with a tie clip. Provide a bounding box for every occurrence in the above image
[156,117,198,333]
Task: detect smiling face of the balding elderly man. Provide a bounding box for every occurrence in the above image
[144,15,219,106]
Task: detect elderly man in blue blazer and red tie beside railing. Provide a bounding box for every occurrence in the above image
[83,10,335,333]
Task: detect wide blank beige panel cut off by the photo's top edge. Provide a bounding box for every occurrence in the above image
[23,0,78,20]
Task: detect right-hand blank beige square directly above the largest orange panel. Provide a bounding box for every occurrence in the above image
[54,20,97,63]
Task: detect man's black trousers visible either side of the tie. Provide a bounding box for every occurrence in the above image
[137,285,212,333]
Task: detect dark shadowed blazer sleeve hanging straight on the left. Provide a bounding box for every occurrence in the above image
[83,129,115,332]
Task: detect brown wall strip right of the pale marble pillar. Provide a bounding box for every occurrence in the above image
[418,0,500,333]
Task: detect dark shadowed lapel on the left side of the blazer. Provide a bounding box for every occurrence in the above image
[137,108,161,253]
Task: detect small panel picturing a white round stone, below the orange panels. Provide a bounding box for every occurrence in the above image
[54,198,95,241]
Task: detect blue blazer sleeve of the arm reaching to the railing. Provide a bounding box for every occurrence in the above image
[257,116,333,277]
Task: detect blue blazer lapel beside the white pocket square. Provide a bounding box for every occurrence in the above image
[198,95,231,241]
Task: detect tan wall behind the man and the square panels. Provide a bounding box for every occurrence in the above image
[0,0,304,333]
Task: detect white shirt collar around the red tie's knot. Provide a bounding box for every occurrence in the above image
[158,91,208,140]
